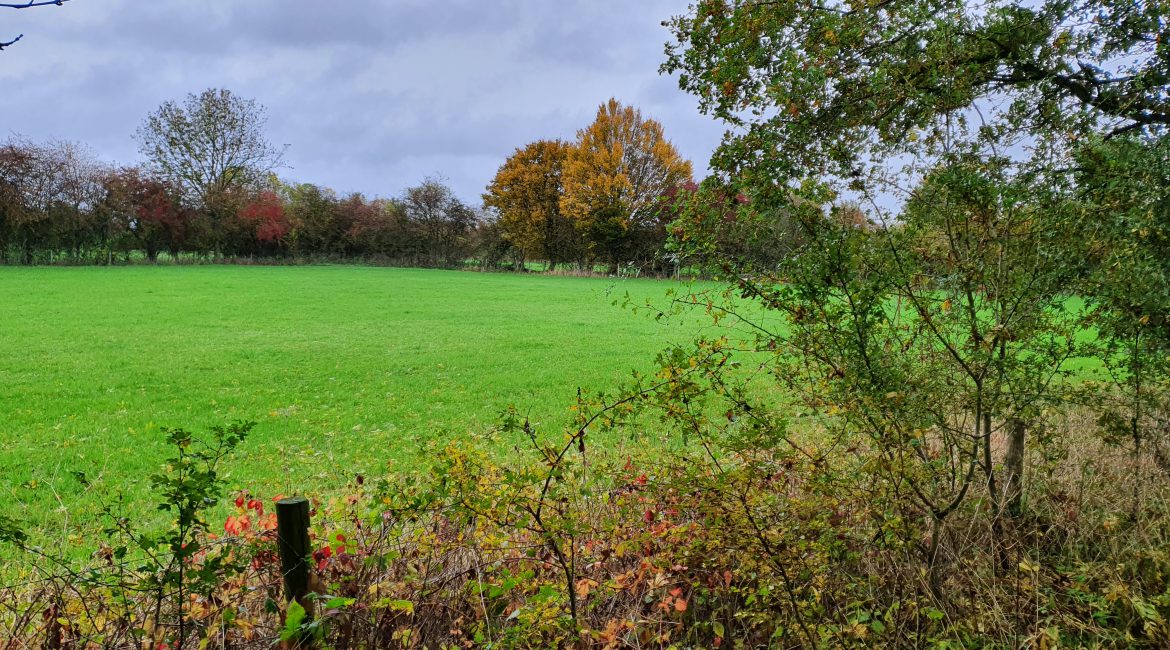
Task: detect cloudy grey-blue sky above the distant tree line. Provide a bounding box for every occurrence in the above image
[0,0,724,205]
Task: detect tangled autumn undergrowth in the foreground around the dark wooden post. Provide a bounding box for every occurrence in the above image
[0,385,1170,649]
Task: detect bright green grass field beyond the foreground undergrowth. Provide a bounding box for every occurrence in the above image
[0,267,701,547]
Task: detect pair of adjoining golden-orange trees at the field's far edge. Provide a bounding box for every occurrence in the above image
[483,99,691,271]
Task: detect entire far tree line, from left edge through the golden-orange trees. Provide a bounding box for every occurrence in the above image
[0,89,694,272]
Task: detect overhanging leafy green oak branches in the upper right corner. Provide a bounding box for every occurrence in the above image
[662,0,1170,192]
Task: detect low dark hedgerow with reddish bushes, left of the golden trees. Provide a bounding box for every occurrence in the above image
[0,132,487,267]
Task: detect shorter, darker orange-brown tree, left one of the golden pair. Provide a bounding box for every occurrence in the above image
[483,140,581,270]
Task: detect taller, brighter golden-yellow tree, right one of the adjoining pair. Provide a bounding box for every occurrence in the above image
[560,98,691,265]
